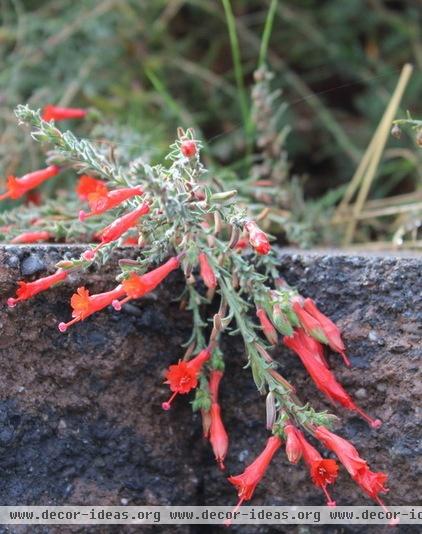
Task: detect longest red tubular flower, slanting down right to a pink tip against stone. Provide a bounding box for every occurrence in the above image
[283,329,381,428]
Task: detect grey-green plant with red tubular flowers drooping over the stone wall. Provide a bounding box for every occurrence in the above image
[3,106,387,520]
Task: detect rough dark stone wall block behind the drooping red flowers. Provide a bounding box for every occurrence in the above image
[0,246,422,534]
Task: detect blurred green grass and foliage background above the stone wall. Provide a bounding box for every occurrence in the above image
[0,0,422,247]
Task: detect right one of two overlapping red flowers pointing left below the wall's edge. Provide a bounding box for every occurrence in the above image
[112,256,180,311]
